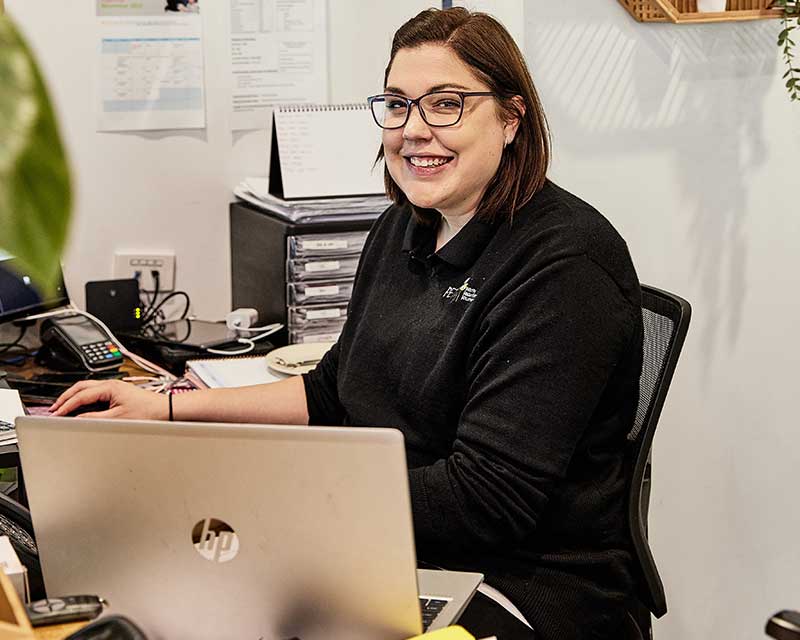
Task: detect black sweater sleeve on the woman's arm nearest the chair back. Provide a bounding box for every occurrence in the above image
[409,255,641,548]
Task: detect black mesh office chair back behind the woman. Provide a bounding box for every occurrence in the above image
[628,285,692,640]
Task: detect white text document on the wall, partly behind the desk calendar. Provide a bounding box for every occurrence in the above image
[230,0,328,130]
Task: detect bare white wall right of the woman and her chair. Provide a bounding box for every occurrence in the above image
[525,0,800,640]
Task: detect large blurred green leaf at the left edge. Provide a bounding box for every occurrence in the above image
[0,15,72,293]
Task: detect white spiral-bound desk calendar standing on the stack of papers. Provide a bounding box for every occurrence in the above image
[269,103,384,200]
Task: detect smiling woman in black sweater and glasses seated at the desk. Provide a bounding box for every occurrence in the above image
[55,9,642,639]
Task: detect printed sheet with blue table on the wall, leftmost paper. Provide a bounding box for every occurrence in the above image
[95,0,209,131]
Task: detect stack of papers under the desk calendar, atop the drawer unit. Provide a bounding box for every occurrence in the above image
[233,178,391,224]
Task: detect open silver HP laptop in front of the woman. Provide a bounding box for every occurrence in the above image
[17,417,482,640]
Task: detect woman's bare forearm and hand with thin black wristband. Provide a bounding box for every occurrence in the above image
[51,376,308,424]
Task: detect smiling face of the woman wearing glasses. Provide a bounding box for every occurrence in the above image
[383,44,518,216]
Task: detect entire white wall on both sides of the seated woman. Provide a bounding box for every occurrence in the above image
[6,0,800,640]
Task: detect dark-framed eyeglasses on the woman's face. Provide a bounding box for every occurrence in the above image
[367,91,495,129]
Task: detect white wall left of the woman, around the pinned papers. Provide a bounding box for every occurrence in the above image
[6,0,427,319]
